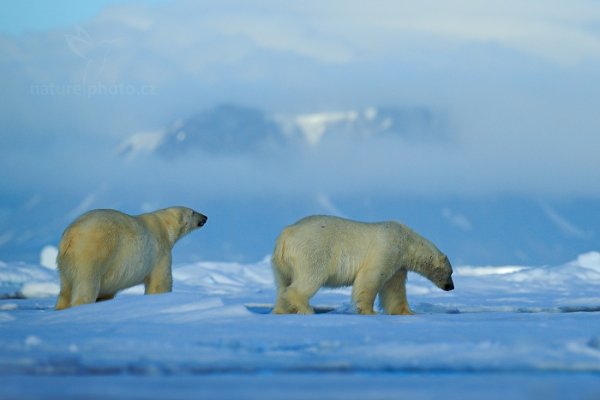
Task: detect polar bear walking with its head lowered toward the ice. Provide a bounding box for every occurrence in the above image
[271,215,454,314]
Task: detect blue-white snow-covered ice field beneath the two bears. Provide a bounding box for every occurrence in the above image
[0,252,600,399]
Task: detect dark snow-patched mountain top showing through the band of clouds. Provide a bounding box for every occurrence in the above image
[117,104,447,158]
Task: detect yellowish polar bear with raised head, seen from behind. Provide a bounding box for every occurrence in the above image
[56,207,207,310]
